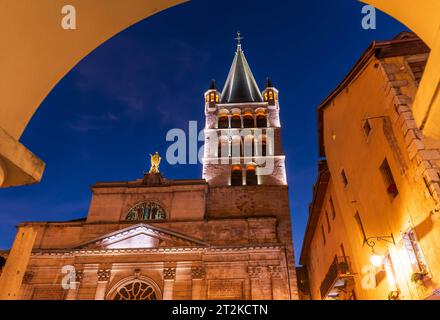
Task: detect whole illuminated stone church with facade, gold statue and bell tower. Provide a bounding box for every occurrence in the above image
[0,36,298,300]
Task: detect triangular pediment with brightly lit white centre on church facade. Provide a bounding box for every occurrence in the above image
[78,224,208,249]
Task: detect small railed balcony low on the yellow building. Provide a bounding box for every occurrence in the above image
[320,257,354,300]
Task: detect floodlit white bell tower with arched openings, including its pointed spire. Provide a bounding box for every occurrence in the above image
[203,33,287,187]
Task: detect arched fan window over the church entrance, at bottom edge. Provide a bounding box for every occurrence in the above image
[106,276,162,300]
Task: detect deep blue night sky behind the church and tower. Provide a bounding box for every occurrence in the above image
[0,0,406,256]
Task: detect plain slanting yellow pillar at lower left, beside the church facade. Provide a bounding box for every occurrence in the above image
[0,226,37,300]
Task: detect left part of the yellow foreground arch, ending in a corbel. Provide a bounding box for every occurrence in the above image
[0,0,186,187]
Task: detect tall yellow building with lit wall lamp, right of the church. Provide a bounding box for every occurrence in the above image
[299,33,440,300]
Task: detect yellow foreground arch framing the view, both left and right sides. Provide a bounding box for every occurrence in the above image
[0,0,440,187]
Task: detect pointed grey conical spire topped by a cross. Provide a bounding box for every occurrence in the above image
[221,33,263,103]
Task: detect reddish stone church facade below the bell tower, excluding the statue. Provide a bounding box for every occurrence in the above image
[0,180,296,300]
